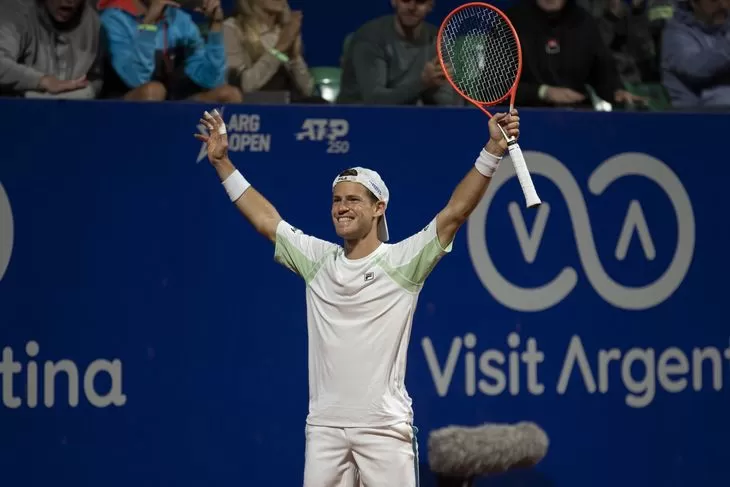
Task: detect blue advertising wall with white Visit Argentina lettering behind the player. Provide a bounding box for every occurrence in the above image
[0,100,730,487]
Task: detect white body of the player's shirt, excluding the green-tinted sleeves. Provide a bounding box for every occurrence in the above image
[307,244,417,425]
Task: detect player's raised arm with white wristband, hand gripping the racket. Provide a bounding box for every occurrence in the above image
[436,109,520,248]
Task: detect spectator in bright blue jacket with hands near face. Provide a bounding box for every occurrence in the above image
[99,0,242,103]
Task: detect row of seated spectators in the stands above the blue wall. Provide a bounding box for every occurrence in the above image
[0,0,730,109]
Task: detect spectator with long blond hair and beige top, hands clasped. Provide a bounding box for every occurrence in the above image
[223,0,324,103]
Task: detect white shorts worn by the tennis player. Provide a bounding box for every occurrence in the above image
[304,423,418,487]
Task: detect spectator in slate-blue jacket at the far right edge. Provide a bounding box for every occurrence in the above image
[662,0,730,107]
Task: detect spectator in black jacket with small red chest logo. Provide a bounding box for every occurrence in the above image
[505,0,643,107]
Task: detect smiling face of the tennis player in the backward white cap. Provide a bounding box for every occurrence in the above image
[332,181,385,240]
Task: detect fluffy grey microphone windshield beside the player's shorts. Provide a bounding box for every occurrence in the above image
[428,422,549,479]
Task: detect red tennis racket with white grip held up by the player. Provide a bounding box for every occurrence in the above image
[437,2,542,208]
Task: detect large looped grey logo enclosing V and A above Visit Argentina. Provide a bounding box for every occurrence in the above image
[467,151,695,311]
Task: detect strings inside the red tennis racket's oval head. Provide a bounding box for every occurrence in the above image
[441,6,520,103]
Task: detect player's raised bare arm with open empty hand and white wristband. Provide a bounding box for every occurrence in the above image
[195,110,281,242]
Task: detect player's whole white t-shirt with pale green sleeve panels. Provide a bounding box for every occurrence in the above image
[274,218,452,428]
